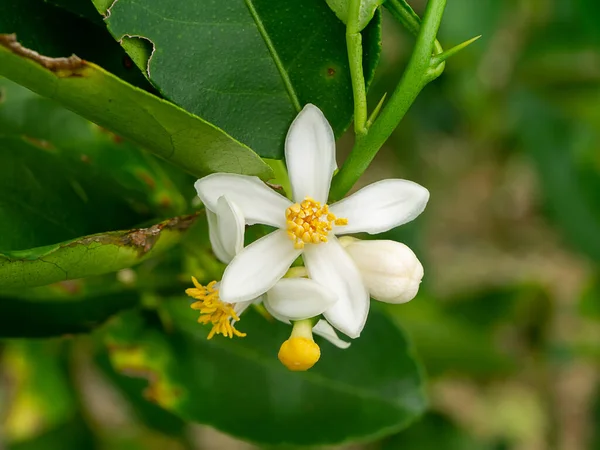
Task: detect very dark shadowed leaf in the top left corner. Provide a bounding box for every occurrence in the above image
[0,0,153,90]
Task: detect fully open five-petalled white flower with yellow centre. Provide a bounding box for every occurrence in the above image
[195,104,429,338]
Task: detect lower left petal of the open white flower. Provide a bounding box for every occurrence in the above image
[219,230,302,303]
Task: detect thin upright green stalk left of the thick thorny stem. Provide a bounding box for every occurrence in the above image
[346,0,367,138]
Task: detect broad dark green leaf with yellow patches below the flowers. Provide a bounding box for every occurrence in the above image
[105,299,425,445]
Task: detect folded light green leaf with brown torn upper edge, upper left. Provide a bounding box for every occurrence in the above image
[0,35,272,179]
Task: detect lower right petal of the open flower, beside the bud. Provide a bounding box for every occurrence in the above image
[304,235,369,338]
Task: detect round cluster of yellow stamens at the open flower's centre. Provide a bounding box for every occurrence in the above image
[285,197,348,249]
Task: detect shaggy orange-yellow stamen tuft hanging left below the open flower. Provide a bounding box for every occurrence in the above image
[185,277,246,339]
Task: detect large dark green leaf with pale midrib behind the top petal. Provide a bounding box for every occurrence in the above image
[93,0,381,159]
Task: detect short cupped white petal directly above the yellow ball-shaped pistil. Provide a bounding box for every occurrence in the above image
[264,278,337,321]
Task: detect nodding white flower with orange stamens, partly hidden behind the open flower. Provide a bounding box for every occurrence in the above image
[195,196,350,348]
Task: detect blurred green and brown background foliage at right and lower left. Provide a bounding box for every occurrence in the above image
[0,0,600,450]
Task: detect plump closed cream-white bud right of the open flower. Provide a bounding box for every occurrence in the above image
[340,236,423,303]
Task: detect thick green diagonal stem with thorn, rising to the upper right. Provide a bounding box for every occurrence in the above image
[330,0,446,202]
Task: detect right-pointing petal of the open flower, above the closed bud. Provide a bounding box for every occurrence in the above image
[329,180,429,234]
